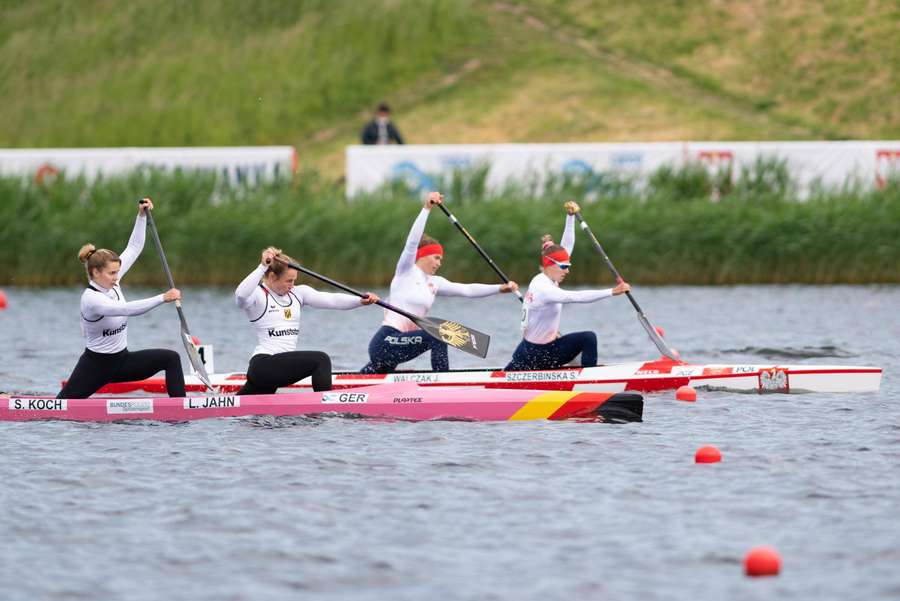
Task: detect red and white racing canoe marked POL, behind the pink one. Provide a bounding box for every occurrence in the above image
[89,359,881,394]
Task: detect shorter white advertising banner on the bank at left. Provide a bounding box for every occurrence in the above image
[0,146,297,185]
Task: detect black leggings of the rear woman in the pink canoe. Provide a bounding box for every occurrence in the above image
[56,349,186,399]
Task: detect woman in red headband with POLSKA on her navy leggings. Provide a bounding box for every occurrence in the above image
[360,192,519,373]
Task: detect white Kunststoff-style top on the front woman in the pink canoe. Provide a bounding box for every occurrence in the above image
[234,265,363,357]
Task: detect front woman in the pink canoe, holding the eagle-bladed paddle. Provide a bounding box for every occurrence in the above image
[234,247,380,395]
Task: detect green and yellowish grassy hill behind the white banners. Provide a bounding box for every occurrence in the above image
[0,0,900,175]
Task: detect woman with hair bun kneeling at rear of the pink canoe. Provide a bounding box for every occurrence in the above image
[56,198,185,399]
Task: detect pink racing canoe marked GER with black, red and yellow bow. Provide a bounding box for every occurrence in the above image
[0,382,644,422]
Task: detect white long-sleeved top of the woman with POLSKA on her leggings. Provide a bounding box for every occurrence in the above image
[381,208,500,332]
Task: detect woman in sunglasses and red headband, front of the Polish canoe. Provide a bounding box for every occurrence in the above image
[504,201,631,371]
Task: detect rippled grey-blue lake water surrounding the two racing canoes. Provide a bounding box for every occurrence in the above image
[0,282,900,601]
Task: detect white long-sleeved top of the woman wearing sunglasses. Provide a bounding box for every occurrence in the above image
[522,215,612,344]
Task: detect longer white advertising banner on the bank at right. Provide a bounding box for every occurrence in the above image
[347,141,900,196]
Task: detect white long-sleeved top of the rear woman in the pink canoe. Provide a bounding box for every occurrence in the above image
[81,215,165,354]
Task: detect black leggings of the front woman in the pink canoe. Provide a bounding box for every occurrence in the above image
[238,351,331,394]
